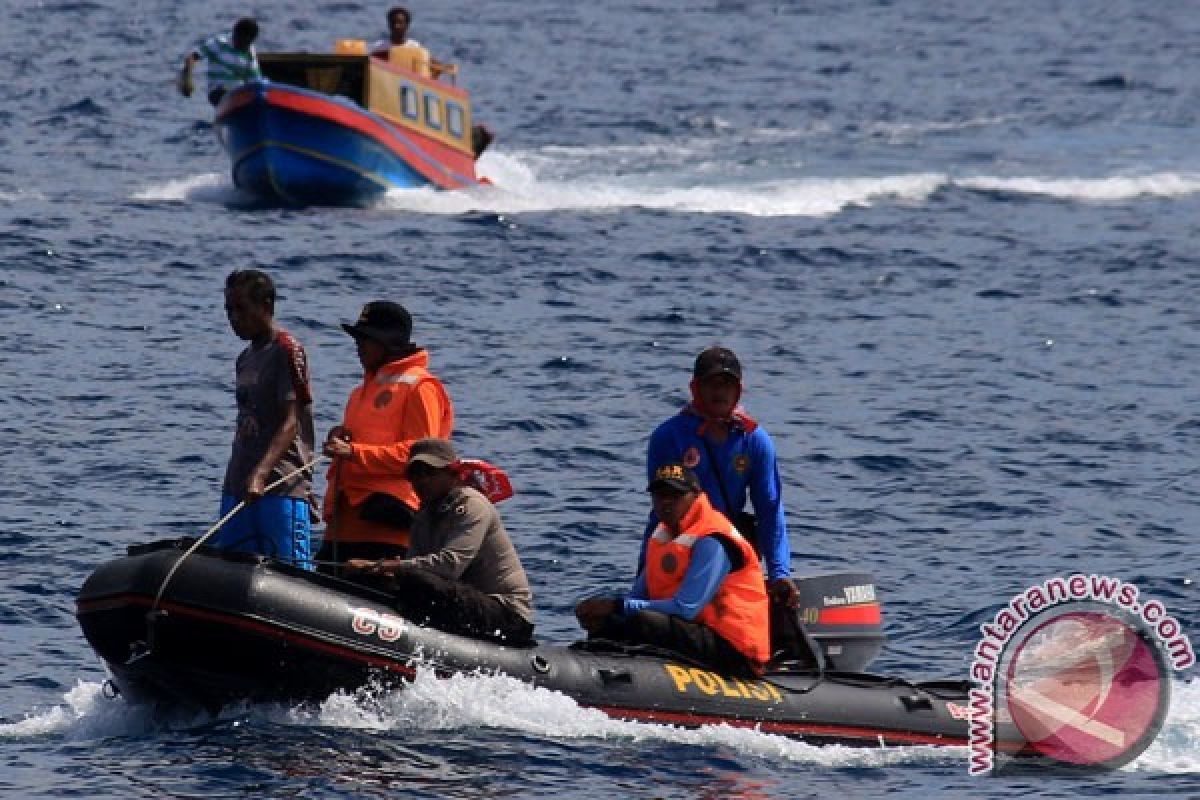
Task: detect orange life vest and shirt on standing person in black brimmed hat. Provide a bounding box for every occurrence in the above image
[324,350,454,545]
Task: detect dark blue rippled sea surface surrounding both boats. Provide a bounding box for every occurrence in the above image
[0,0,1200,800]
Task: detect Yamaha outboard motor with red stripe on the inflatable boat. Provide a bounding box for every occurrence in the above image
[772,572,887,672]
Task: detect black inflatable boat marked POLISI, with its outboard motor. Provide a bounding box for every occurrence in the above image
[77,540,1003,746]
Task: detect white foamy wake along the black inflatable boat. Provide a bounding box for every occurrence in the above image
[9,669,1200,775]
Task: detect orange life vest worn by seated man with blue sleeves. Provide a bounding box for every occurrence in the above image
[646,493,770,667]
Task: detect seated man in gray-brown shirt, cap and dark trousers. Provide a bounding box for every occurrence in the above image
[346,439,533,644]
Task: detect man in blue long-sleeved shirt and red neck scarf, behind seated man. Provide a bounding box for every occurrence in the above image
[638,347,798,607]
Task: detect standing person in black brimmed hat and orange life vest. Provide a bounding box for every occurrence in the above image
[317,300,454,566]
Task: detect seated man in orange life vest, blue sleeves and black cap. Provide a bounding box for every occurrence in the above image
[575,463,770,674]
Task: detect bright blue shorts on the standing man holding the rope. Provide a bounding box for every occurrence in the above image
[208,494,312,570]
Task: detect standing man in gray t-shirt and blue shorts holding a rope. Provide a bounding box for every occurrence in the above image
[216,270,314,570]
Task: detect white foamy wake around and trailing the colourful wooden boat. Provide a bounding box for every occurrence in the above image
[133,139,1200,217]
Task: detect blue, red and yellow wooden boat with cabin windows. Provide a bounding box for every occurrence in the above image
[215,41,490,205]
